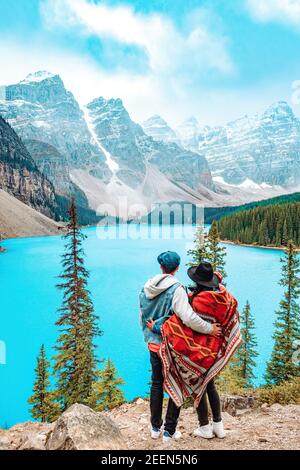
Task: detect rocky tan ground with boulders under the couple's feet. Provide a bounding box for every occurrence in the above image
[0,396,300,451]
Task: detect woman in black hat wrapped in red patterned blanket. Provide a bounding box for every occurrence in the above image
[160,262,241,439]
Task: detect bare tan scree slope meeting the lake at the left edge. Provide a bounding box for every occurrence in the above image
[0,189,61,238]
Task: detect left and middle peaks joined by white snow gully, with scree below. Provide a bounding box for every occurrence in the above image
[0,72,214,217]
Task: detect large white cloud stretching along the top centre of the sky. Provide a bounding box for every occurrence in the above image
[41,0,234,76]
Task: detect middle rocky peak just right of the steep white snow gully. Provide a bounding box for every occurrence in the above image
[87,98,213,191]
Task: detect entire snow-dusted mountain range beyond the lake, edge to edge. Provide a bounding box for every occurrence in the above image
[0,72,300,220]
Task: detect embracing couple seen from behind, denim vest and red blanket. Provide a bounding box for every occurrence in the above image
[140,251,241,442]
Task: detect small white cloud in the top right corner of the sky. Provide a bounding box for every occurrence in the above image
[246,0,300,26]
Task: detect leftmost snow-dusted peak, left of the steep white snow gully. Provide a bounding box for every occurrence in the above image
[0,72,111,192]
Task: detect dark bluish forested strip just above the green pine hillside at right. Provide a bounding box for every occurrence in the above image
[204,193,300,224]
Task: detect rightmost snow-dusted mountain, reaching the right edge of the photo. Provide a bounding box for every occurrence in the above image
[176,101,300,189]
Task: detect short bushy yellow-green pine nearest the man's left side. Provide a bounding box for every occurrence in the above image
[92,359,125,411]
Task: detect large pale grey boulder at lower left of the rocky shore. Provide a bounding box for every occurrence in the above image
[46,404,126,450]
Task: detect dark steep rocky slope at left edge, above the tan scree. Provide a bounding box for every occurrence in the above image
[0,117,61,218]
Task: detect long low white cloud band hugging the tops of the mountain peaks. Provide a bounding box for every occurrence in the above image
[0,38,291,126]
